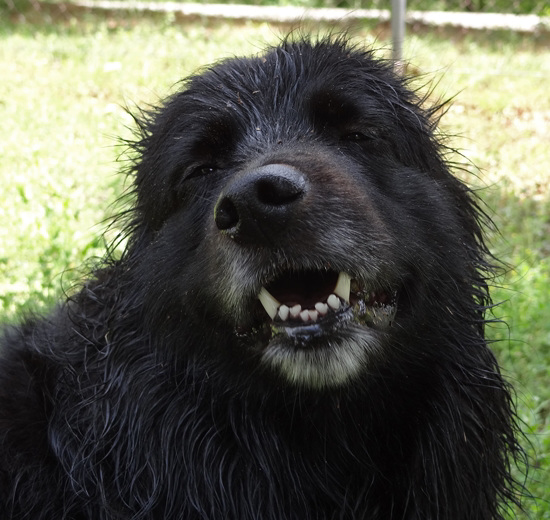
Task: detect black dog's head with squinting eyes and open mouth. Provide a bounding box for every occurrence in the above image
[127,36,490,387]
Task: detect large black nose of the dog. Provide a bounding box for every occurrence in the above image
[214,164,307,244]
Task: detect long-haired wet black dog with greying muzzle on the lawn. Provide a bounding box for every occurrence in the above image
[0,38,519,520]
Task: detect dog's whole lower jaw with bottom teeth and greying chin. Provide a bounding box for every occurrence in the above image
[236,276,397,389]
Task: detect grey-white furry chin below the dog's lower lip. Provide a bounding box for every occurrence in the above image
[261,324,381,389]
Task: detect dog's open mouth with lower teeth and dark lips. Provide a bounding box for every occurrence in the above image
[258,270,398,337]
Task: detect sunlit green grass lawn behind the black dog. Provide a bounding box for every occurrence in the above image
[0,13,550,519]
